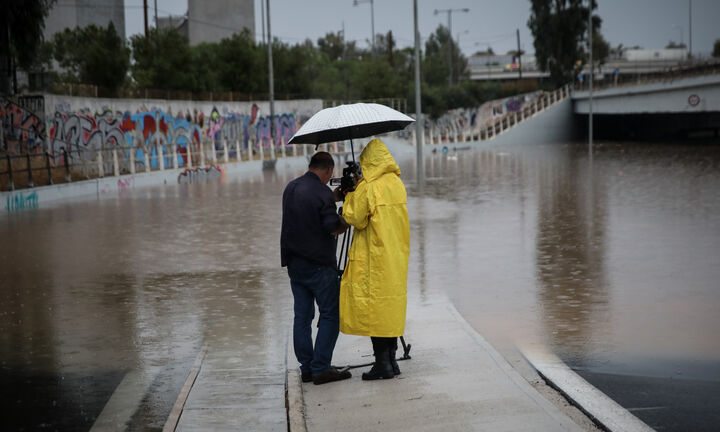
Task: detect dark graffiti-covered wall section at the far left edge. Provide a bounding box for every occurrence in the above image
[0,98,45,154]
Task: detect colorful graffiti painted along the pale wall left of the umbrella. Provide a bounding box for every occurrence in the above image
[47,104,298,170]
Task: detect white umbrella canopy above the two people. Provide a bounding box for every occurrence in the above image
[288,103,415,145]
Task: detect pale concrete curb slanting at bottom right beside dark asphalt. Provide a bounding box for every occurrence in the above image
[518,347,654,432]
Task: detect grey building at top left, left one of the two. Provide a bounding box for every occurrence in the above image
[43,0,125,40]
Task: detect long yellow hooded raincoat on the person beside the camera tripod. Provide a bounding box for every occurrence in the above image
[340,139,410,337]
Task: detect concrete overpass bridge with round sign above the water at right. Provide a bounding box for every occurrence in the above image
[571,70,720,139]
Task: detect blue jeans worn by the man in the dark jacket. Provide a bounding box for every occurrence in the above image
[288,257,340,375]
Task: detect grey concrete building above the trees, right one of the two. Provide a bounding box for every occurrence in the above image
[187,0,255,45]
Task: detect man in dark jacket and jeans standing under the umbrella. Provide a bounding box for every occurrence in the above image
[280,152,351,384]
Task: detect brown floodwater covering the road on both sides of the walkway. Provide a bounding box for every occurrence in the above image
[0,143,720,431]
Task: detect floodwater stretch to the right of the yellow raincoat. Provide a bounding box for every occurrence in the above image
[401,143,720,379]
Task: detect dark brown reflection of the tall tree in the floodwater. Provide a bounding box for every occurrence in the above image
[535,149,611,363]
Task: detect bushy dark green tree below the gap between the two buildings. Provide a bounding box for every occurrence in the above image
[130,28,197,90]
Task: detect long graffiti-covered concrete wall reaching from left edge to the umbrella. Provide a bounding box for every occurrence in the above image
[0,95,322,166]
